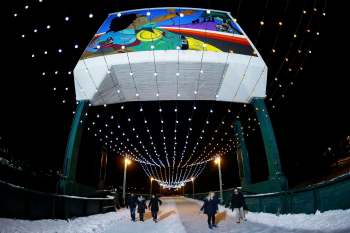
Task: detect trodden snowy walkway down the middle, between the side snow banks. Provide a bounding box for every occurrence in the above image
[105,197,349,233]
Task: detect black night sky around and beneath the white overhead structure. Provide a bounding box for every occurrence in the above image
[0,0,350,192]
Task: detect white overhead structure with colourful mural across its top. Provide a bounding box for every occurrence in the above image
[74,8,267,105]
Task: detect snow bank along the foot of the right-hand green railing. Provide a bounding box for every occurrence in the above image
[189,199,350,233]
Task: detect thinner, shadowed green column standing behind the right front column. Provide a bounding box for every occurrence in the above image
[234,121,251,188]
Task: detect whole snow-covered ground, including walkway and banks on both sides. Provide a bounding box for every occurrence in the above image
[0,197,350,233]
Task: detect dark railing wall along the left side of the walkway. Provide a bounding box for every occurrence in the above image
[0,181,114,219]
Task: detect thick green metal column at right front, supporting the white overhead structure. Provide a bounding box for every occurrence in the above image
[251,98,288,191]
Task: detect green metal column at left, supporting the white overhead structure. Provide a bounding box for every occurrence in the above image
[59,101,89,194]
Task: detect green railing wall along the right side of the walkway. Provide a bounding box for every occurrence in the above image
[187,174,350,214]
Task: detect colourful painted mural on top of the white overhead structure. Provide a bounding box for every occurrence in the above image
[82,8,254,59]
